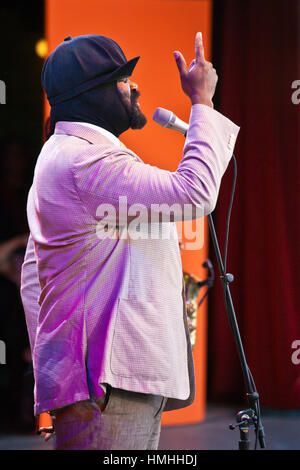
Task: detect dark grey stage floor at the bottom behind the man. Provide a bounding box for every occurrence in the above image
[0,405,300,450]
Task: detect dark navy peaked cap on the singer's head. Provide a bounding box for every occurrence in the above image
[42,35,140,106]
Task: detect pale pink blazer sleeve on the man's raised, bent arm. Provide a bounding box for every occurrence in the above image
[72,104,240,221]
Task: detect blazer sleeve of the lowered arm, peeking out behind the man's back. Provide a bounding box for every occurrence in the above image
[20,234,41,352]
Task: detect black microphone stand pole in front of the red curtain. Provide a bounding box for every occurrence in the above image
[208,214,265,450]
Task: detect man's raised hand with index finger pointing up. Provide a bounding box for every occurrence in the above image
[174,33,218,108]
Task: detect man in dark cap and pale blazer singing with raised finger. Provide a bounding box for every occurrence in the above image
[21,33,239,450]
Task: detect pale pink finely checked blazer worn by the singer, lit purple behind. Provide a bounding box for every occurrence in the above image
[21,104,239,415]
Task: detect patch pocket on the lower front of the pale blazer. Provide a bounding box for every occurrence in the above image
[111,299,171,380]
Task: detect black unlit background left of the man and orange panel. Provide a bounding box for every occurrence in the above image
[0,1,44,431]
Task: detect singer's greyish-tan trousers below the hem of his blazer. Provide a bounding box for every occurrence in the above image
[54,385,167,450]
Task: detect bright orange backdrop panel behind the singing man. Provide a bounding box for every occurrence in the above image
[45,0,212,425]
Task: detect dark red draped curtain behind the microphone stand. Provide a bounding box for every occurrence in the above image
[208,0,300,409]
